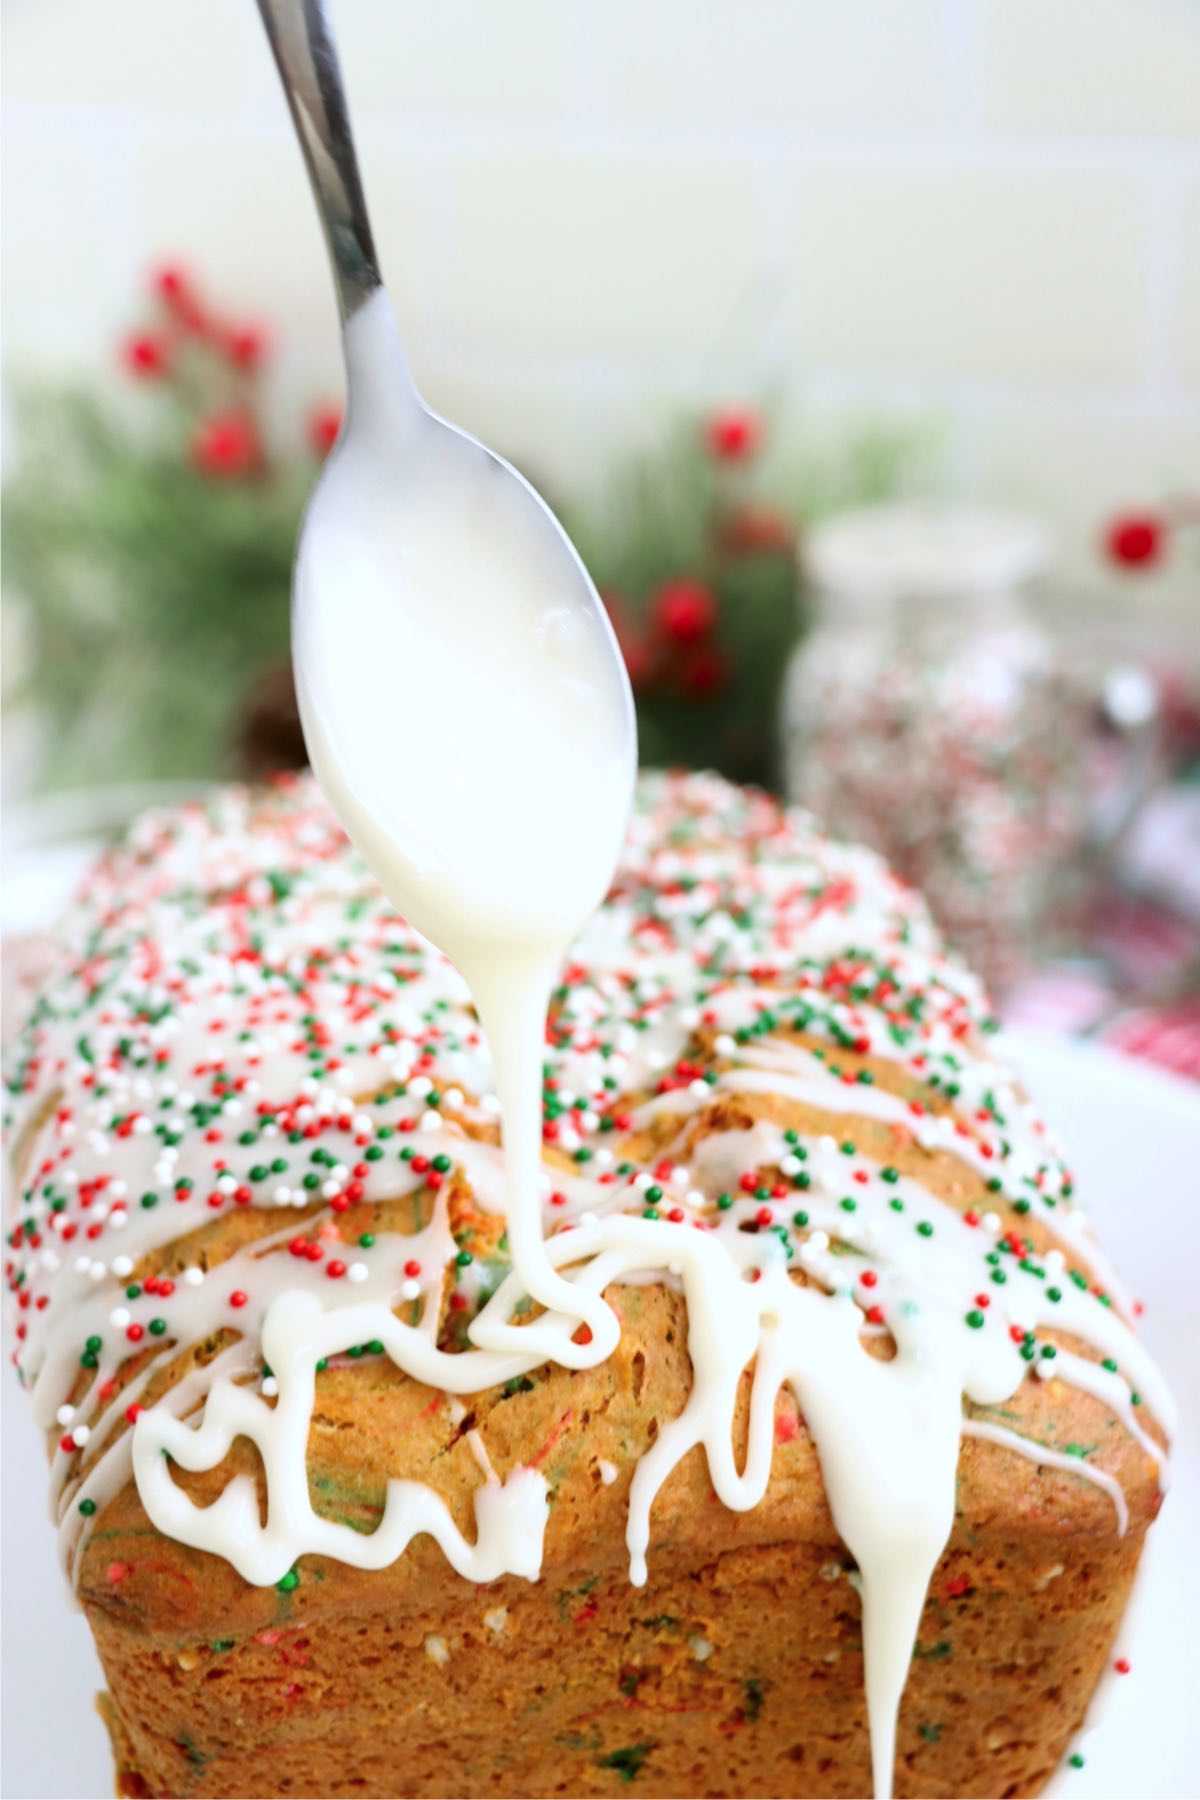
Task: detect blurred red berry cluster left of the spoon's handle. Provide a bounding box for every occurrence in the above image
[121,263,342,481]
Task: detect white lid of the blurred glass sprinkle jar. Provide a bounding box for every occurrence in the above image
[802,506,1051,601]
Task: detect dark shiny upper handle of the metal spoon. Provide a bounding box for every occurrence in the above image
[259,0,383,324]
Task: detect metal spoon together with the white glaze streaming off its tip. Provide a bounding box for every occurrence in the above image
[261,0,637,1363]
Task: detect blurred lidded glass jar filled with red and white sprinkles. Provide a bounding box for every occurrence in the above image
[783,506,1090,986]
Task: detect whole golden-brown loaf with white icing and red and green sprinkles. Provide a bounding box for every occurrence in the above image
[5,776,1169,1796]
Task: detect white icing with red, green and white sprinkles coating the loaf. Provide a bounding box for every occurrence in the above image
[7,778,1171,1795]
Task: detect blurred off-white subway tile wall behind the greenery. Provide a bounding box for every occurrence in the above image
[4,0,1200,608]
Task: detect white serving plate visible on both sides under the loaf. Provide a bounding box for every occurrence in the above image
[0,964,1200,1800]
